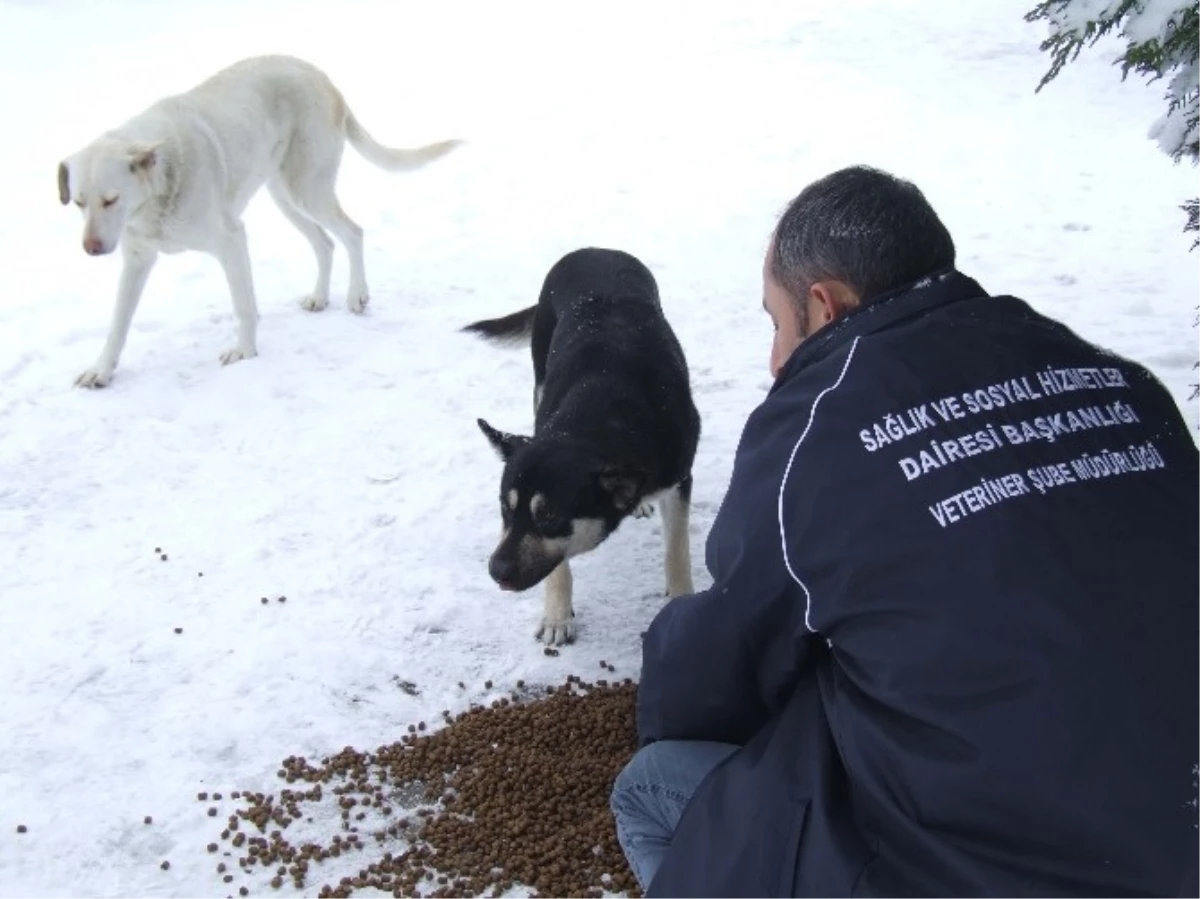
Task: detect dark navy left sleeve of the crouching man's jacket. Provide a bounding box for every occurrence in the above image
[637,396,817,745]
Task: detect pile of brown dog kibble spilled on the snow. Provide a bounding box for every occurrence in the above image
[206,665,641,899]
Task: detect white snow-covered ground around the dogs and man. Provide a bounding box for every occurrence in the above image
[0,0,1200,899]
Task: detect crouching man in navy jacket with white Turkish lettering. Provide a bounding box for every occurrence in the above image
[612,168,1200,899]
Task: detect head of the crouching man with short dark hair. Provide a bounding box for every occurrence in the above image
[762,166,954,377]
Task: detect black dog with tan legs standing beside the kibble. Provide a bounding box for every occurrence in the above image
[463,248,700,643]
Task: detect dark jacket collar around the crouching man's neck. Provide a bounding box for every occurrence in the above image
[768,268,989,395]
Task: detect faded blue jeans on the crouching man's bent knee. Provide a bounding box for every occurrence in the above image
[610,741,738,891]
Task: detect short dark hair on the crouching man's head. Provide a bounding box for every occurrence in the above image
[770,166,954,302]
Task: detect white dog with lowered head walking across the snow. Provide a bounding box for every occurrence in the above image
[59,56,462,388]
